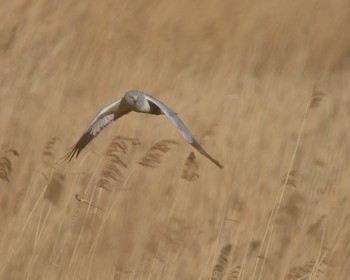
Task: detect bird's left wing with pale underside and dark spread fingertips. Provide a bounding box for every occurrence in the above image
[64,98,131,162]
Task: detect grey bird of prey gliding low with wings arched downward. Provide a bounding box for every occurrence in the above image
[64,90,223,168]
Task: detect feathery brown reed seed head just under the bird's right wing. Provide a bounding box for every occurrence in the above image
[138,139,178,168]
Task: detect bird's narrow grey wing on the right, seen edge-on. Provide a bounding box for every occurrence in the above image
[145,93,223,168]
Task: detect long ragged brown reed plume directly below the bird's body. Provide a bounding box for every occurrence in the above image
[97,136,141,191]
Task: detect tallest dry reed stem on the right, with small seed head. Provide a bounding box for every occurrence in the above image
[252,84,323,280]
